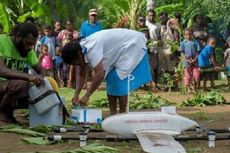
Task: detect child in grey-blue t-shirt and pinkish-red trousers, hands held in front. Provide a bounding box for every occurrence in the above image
[179,28,200,93]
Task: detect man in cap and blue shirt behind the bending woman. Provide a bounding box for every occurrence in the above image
[80,9,102,38]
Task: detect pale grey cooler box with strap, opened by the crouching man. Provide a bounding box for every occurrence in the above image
[28,78,65,126]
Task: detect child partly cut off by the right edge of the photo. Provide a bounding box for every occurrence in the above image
[224,39,230,90]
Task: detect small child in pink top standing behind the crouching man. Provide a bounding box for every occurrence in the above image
[39,45,53,77]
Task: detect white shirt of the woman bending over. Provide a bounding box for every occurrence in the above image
[80,29,147,80]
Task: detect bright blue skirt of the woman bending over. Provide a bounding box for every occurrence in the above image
[105,53,152,96]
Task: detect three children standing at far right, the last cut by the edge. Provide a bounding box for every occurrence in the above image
[179,28,230,92]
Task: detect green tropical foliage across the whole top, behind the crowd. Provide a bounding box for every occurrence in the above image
[0,0,230,32]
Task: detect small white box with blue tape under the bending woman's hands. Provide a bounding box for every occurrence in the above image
[71,109,102,124]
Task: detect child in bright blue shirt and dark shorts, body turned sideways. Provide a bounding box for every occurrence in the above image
[198,37,216,90]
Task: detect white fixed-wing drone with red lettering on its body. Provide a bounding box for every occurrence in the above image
[102,106,198,153]
